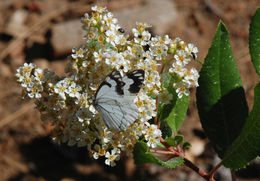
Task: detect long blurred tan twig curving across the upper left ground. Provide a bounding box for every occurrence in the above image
[0,0,143,61]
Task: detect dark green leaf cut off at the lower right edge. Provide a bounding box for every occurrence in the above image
[223,83,260,169]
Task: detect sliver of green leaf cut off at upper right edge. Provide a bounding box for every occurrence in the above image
[249,8,260,76]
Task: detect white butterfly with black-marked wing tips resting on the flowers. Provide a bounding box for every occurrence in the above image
[92,69,145,131]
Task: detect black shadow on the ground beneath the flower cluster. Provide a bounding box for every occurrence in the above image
[10,137,137,181]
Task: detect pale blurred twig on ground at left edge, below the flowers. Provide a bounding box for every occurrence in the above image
[0,103,34,129]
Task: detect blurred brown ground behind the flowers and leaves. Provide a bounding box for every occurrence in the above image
[0,0,260,181]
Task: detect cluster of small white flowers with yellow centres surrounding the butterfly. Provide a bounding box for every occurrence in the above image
[16,6,198,166]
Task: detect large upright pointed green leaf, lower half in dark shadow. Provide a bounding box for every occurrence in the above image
[196,22,248,158]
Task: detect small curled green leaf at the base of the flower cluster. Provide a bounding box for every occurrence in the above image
[134,141,184,168]
